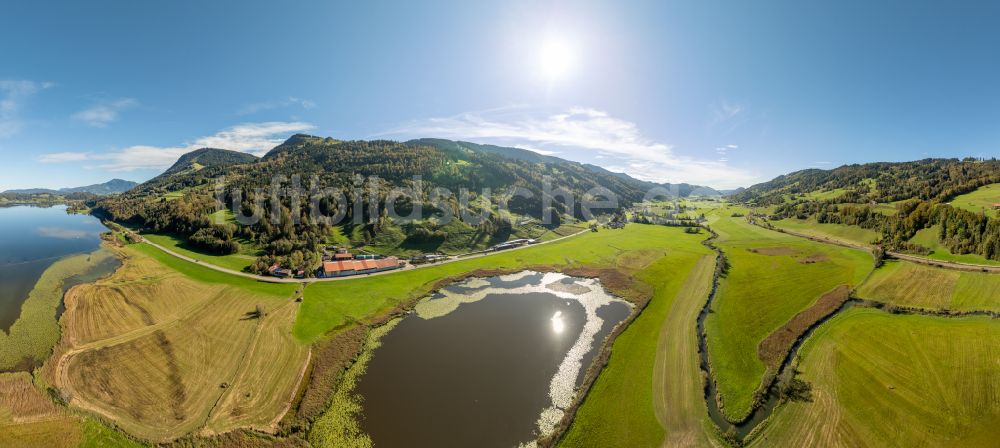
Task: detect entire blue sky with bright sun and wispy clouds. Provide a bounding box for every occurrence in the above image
[0,1,1000,190]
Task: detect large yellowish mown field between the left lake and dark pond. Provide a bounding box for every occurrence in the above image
[51,245,309,442]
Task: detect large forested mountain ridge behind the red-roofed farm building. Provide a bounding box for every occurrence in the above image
[95,134,717,267]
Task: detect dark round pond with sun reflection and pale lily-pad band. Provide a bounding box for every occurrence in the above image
[356,272,631,447]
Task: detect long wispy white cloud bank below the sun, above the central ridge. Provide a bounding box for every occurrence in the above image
[379,106,758,188]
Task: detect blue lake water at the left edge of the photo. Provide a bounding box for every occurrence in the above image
[0,206,106,331]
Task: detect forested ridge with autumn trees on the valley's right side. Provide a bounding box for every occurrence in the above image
[731,158,1000,260]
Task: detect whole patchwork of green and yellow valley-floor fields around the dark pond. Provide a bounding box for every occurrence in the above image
[0,215,1000,447]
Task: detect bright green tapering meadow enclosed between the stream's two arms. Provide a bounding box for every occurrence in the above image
[705,211,873,420]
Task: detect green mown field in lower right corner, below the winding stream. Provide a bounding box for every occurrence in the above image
[753,307,1000,447]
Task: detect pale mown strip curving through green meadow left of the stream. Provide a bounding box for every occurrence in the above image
[653,255,715,447]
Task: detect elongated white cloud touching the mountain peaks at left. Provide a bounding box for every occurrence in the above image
[38,121,315,171]
